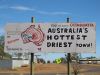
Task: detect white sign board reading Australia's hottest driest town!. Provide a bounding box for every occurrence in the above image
[5,23,96,53]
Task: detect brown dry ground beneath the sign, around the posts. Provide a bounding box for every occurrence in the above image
[0,64,100,75]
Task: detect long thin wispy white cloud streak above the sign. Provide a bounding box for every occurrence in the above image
[0,6,71,15]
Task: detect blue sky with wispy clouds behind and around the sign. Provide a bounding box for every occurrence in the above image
[0,0,100,58]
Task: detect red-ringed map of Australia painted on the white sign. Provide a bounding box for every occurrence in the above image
[21,25,44,46]
